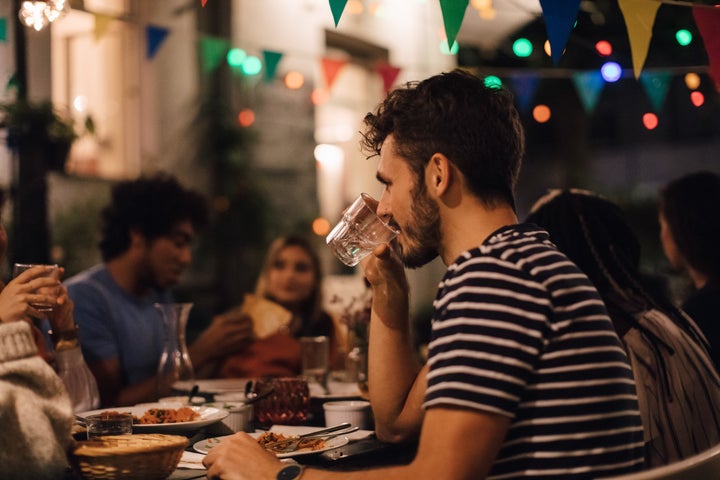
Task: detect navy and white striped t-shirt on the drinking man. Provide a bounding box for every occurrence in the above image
[425,224,643,480]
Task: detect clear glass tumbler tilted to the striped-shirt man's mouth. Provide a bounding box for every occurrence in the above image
[325,193,400,267]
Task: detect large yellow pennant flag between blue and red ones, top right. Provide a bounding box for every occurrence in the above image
[618,0,661,78]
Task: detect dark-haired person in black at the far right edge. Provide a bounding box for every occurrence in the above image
[659,172,720,368]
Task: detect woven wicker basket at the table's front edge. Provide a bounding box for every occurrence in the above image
[73,433,188,480]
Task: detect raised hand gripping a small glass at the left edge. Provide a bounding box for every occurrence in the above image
[0,265,61,322]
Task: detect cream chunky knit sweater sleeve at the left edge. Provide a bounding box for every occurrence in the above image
[0,322,73,480]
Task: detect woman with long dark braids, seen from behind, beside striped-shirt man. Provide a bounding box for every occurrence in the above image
[527,190,720,467]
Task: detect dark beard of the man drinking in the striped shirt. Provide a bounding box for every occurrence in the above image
[400,186,440,268]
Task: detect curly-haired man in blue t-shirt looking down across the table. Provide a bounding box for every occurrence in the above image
[66,174,255,406]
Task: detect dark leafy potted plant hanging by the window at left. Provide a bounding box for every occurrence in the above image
[0,100,77,171]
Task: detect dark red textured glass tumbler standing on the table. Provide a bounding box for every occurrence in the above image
[255,377,310,426]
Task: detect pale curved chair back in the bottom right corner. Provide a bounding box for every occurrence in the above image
[603,444,720,480]
